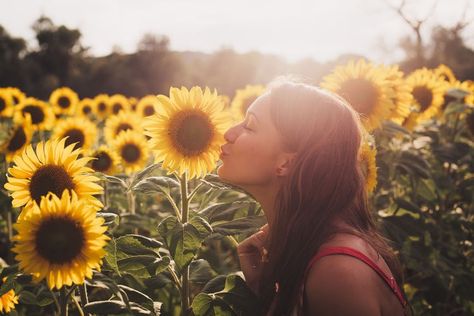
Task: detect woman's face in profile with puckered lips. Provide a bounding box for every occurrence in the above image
[217,94,284,189]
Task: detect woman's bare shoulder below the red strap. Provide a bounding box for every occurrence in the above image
[305,255,381,316]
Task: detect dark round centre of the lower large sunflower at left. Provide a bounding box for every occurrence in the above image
[35,216,85,264]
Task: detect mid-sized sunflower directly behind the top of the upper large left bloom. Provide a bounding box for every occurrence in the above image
[51,117,97,150]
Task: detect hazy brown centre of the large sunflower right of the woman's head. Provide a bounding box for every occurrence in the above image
[338,78,379,116]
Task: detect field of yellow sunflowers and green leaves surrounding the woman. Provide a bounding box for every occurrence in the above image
[0,60,474,315]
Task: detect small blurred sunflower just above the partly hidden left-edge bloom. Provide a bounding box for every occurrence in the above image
[13,98,56,130]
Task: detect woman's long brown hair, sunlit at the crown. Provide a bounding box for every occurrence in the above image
[259,79,402,315]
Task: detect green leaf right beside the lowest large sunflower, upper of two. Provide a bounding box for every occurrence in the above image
[116,234,162,255]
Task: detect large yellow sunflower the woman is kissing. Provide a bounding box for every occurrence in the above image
[144,87,230,178]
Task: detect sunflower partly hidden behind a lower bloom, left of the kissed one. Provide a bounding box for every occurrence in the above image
[104,111,143,144]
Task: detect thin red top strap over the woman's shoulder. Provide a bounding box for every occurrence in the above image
[305,247,407,307]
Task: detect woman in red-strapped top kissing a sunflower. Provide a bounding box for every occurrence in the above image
[218,81,407,316]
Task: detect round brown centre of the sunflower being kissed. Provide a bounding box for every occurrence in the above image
[169,111,214,156]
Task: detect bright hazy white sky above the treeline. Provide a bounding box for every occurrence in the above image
[0,0,474,63]
